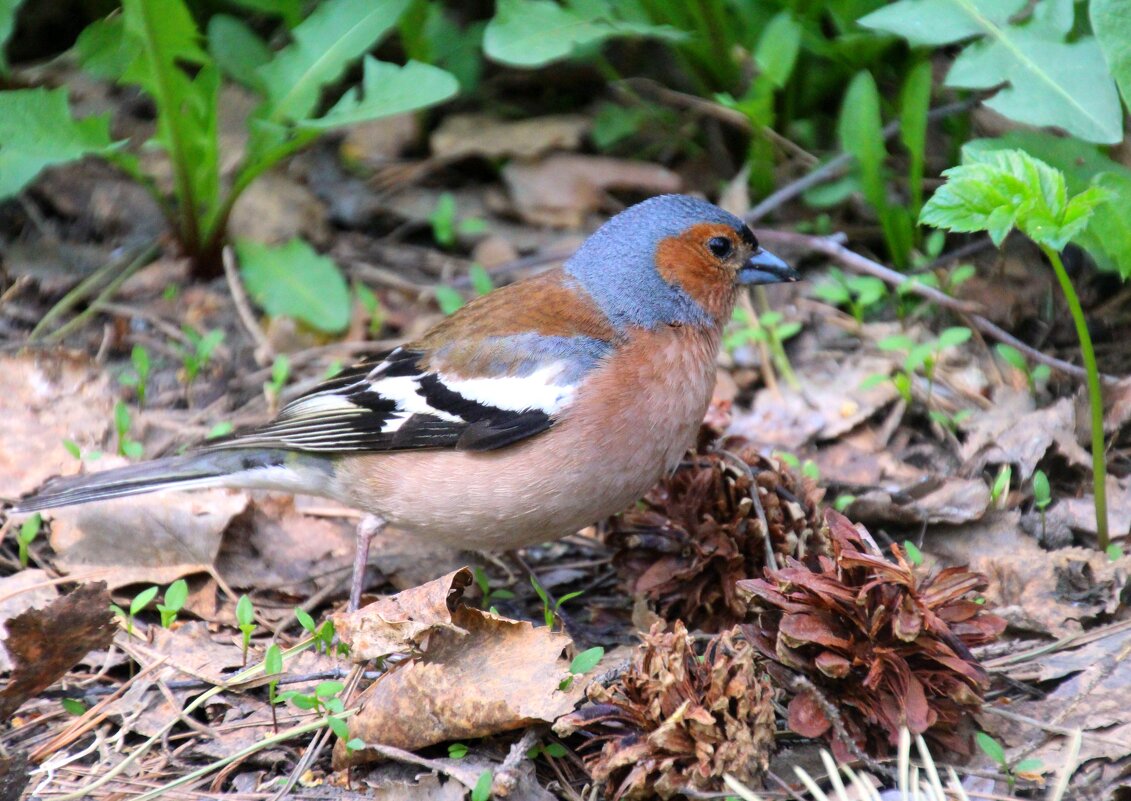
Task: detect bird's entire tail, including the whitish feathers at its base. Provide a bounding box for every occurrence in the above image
[10,448,334,514]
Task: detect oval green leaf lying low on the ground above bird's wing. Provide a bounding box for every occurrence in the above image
[242,239,349,334]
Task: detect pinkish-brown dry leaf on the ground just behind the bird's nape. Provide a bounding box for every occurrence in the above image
[502,154,682,229]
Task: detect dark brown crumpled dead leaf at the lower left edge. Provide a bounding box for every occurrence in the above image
[0,583,115,721]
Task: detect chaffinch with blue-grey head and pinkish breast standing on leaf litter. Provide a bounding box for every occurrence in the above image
[10,195,801,610]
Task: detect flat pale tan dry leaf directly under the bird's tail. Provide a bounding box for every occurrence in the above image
[50,490,248,589]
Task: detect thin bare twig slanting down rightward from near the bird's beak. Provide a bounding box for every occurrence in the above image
[757,230,1119,384]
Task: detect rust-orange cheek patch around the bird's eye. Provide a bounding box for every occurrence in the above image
[656,223,737,320]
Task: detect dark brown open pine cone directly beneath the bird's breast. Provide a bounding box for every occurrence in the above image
[610,437,828,631]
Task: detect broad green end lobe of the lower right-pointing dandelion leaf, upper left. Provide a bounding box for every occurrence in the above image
[301,55,459,130]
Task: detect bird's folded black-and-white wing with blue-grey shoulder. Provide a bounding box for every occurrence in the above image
[206,334,611,453]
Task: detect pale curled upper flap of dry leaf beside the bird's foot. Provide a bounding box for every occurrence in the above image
[331,568,474,660]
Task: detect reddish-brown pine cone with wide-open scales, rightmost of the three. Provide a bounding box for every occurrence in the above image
[739,509,1005,759]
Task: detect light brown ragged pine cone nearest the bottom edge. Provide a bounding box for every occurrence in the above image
[554,621,774,801]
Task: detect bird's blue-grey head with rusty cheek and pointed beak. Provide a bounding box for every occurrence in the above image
[566,195,801,328]
